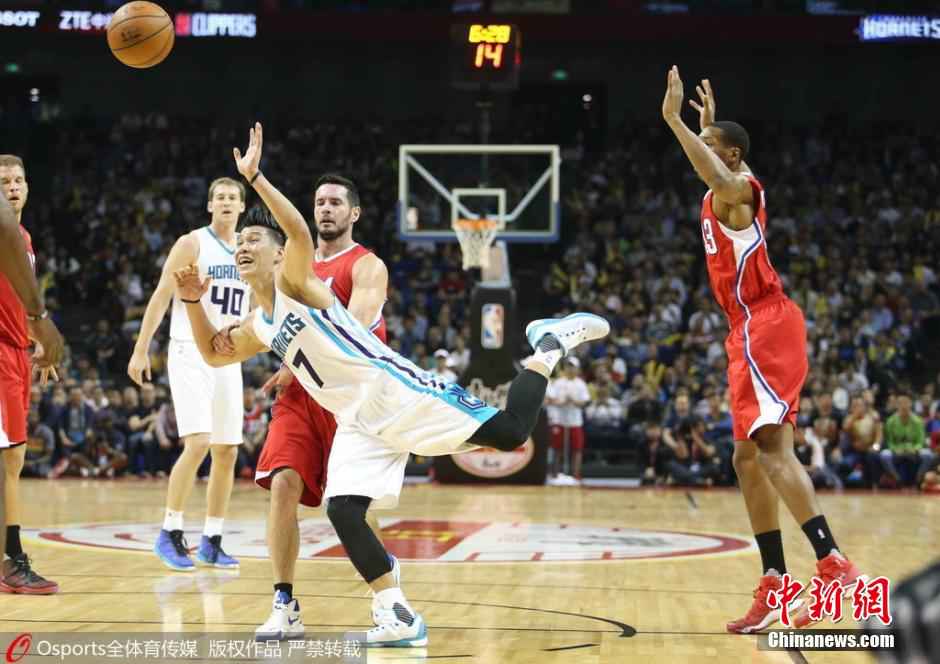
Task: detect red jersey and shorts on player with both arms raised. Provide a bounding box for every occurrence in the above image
[701,174,809,440]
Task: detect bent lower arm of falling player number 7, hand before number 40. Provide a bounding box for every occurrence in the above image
[173,265,267,367]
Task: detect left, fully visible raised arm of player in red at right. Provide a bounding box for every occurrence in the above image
[663,66,754,205]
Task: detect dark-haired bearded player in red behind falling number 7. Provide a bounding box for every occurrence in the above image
[246,175,397,638]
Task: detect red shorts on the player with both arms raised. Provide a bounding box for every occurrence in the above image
[725,298,809,440]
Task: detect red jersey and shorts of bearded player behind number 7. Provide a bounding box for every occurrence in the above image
[255,244,386,507]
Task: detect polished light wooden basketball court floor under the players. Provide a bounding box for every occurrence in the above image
[0,480,940,664]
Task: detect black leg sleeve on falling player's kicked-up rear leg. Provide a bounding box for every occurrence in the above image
[468,369,548,452]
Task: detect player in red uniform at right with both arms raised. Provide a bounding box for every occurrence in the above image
[663,67,860,633]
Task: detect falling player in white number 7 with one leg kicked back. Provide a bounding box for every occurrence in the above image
[176,124,610,647]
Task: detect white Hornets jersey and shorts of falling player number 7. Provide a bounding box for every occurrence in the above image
[252,287,499,508]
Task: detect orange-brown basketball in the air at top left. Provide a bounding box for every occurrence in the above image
[108,0,176,69]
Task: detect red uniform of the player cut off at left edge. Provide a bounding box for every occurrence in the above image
[0,226,36,448]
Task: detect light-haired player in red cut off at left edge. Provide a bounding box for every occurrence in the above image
[0,155,63,595]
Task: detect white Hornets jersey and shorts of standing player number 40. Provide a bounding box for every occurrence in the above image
[167,226,251,445]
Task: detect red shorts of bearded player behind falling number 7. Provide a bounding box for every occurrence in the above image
[255,380,336,507]
